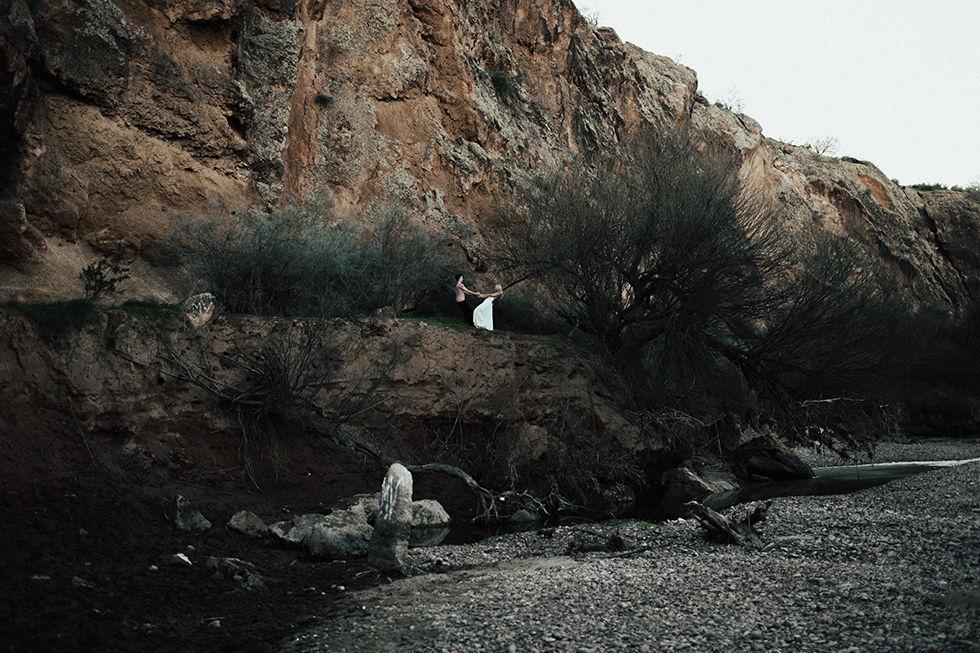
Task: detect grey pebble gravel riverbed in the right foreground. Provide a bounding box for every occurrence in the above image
[288,440,980,653]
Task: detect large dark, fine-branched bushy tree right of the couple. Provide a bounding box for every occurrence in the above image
[489,130,920,407]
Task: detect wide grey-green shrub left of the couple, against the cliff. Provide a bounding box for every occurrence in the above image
[158,196,460,317]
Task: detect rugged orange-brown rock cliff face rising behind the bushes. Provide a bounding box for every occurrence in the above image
[0,0,980,309]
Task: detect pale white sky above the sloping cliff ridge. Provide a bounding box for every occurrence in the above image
[575,0,980,186]
